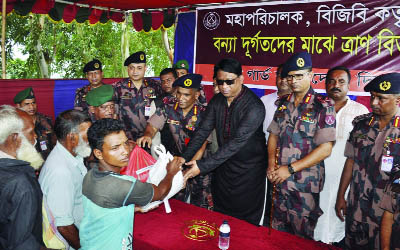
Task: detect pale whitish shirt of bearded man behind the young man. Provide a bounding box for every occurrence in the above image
[39,141,87,229]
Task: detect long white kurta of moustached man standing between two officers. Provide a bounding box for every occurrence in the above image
[314,97,369,243]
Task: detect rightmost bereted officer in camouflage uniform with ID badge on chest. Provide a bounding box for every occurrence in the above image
[336,73,400,250]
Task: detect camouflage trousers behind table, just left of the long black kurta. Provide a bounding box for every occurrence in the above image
[173,173,214,210]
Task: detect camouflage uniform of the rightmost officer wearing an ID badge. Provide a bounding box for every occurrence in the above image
[345,111,400,249]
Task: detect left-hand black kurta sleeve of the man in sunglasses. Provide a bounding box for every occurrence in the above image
[182,98,217,162]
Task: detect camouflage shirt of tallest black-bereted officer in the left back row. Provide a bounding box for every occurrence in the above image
[113,79,162,141]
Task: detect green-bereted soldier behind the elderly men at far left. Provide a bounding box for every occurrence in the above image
[14,87,57,160]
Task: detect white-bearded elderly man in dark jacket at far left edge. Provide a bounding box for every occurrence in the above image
[0,105,46,250]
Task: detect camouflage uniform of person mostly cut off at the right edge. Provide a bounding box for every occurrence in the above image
[381,171,400,250]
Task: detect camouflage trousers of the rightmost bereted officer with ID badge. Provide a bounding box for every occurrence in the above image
[345,218,380,250]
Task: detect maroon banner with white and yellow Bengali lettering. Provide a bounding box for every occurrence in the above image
[194,0,400,95]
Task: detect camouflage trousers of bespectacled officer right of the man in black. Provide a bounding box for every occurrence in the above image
[272,187,323,239]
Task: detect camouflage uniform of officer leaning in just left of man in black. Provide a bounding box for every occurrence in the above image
[148,101,213,209]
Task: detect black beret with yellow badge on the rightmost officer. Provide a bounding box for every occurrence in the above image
[364,73,400,94]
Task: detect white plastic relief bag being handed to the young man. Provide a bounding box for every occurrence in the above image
[142,144,183,213]
